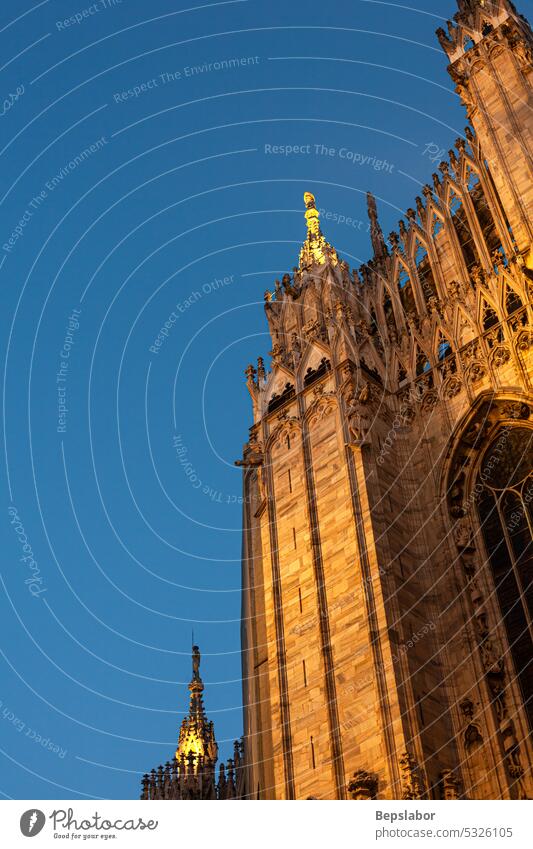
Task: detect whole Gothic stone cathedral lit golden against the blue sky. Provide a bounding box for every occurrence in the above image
[142,0,533,800]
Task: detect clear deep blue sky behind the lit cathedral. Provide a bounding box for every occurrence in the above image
[0,0,533,799]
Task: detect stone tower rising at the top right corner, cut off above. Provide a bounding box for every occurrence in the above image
[437,0,533,250]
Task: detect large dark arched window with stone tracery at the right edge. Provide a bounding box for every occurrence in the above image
[478,427,533,729]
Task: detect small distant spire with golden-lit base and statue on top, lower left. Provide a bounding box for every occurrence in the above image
[176,646,218,764]
